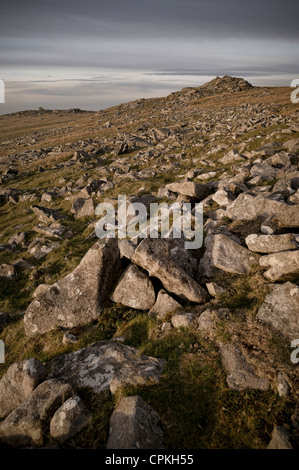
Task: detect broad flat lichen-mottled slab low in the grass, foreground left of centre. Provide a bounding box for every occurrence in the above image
[50,341,164,393]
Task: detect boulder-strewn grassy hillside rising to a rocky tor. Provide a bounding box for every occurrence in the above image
[0,76,299,448]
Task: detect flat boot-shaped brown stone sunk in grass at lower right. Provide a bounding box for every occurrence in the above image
[220,344,269,390]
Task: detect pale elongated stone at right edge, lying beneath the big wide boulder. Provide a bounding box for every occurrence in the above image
[245,233,298,253]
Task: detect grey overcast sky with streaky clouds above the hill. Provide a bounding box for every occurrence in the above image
[0,0,299,114]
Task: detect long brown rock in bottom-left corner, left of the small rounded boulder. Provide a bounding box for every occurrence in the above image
[0,379,73,447]
